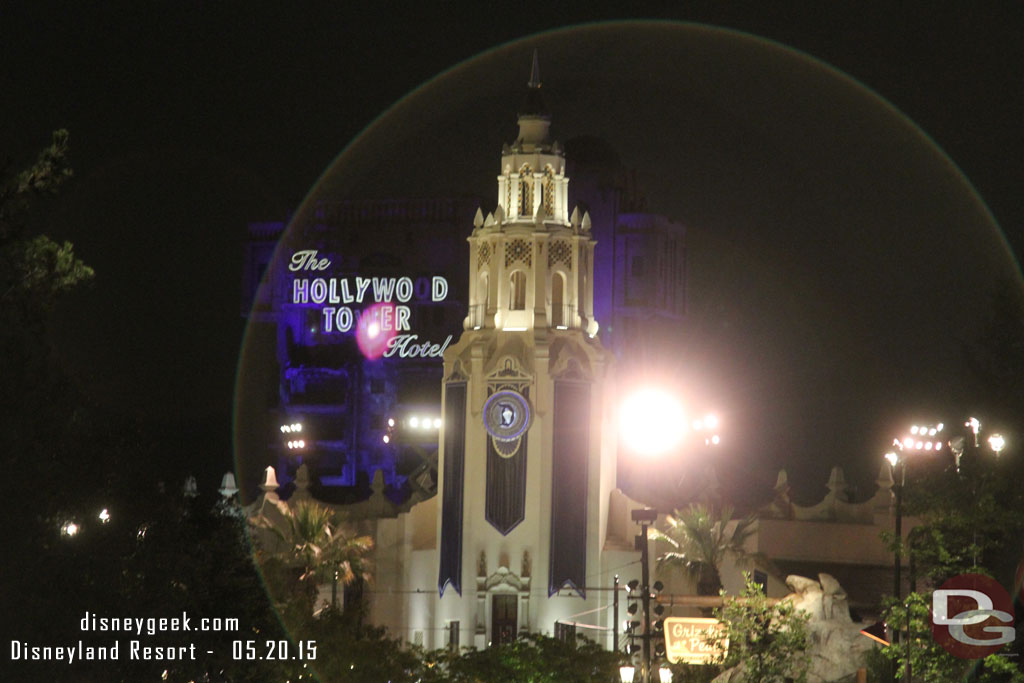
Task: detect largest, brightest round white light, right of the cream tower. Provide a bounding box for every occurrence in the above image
[618,389,686,456]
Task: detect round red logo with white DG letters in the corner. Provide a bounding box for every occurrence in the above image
[932,573,1017,659]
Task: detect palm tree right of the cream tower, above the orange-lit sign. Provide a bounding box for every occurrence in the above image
[651,503,760,595]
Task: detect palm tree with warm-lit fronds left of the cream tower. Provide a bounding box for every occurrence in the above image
[253,501,374,607]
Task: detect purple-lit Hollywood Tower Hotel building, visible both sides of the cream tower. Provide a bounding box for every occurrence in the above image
[243,149,686,500]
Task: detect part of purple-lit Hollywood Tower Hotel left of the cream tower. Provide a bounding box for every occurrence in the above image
[243,199,478,496]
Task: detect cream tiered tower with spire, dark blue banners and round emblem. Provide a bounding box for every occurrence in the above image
[372,56,635,647]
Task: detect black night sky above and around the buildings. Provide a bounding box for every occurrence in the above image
[0,2,1024,505]
